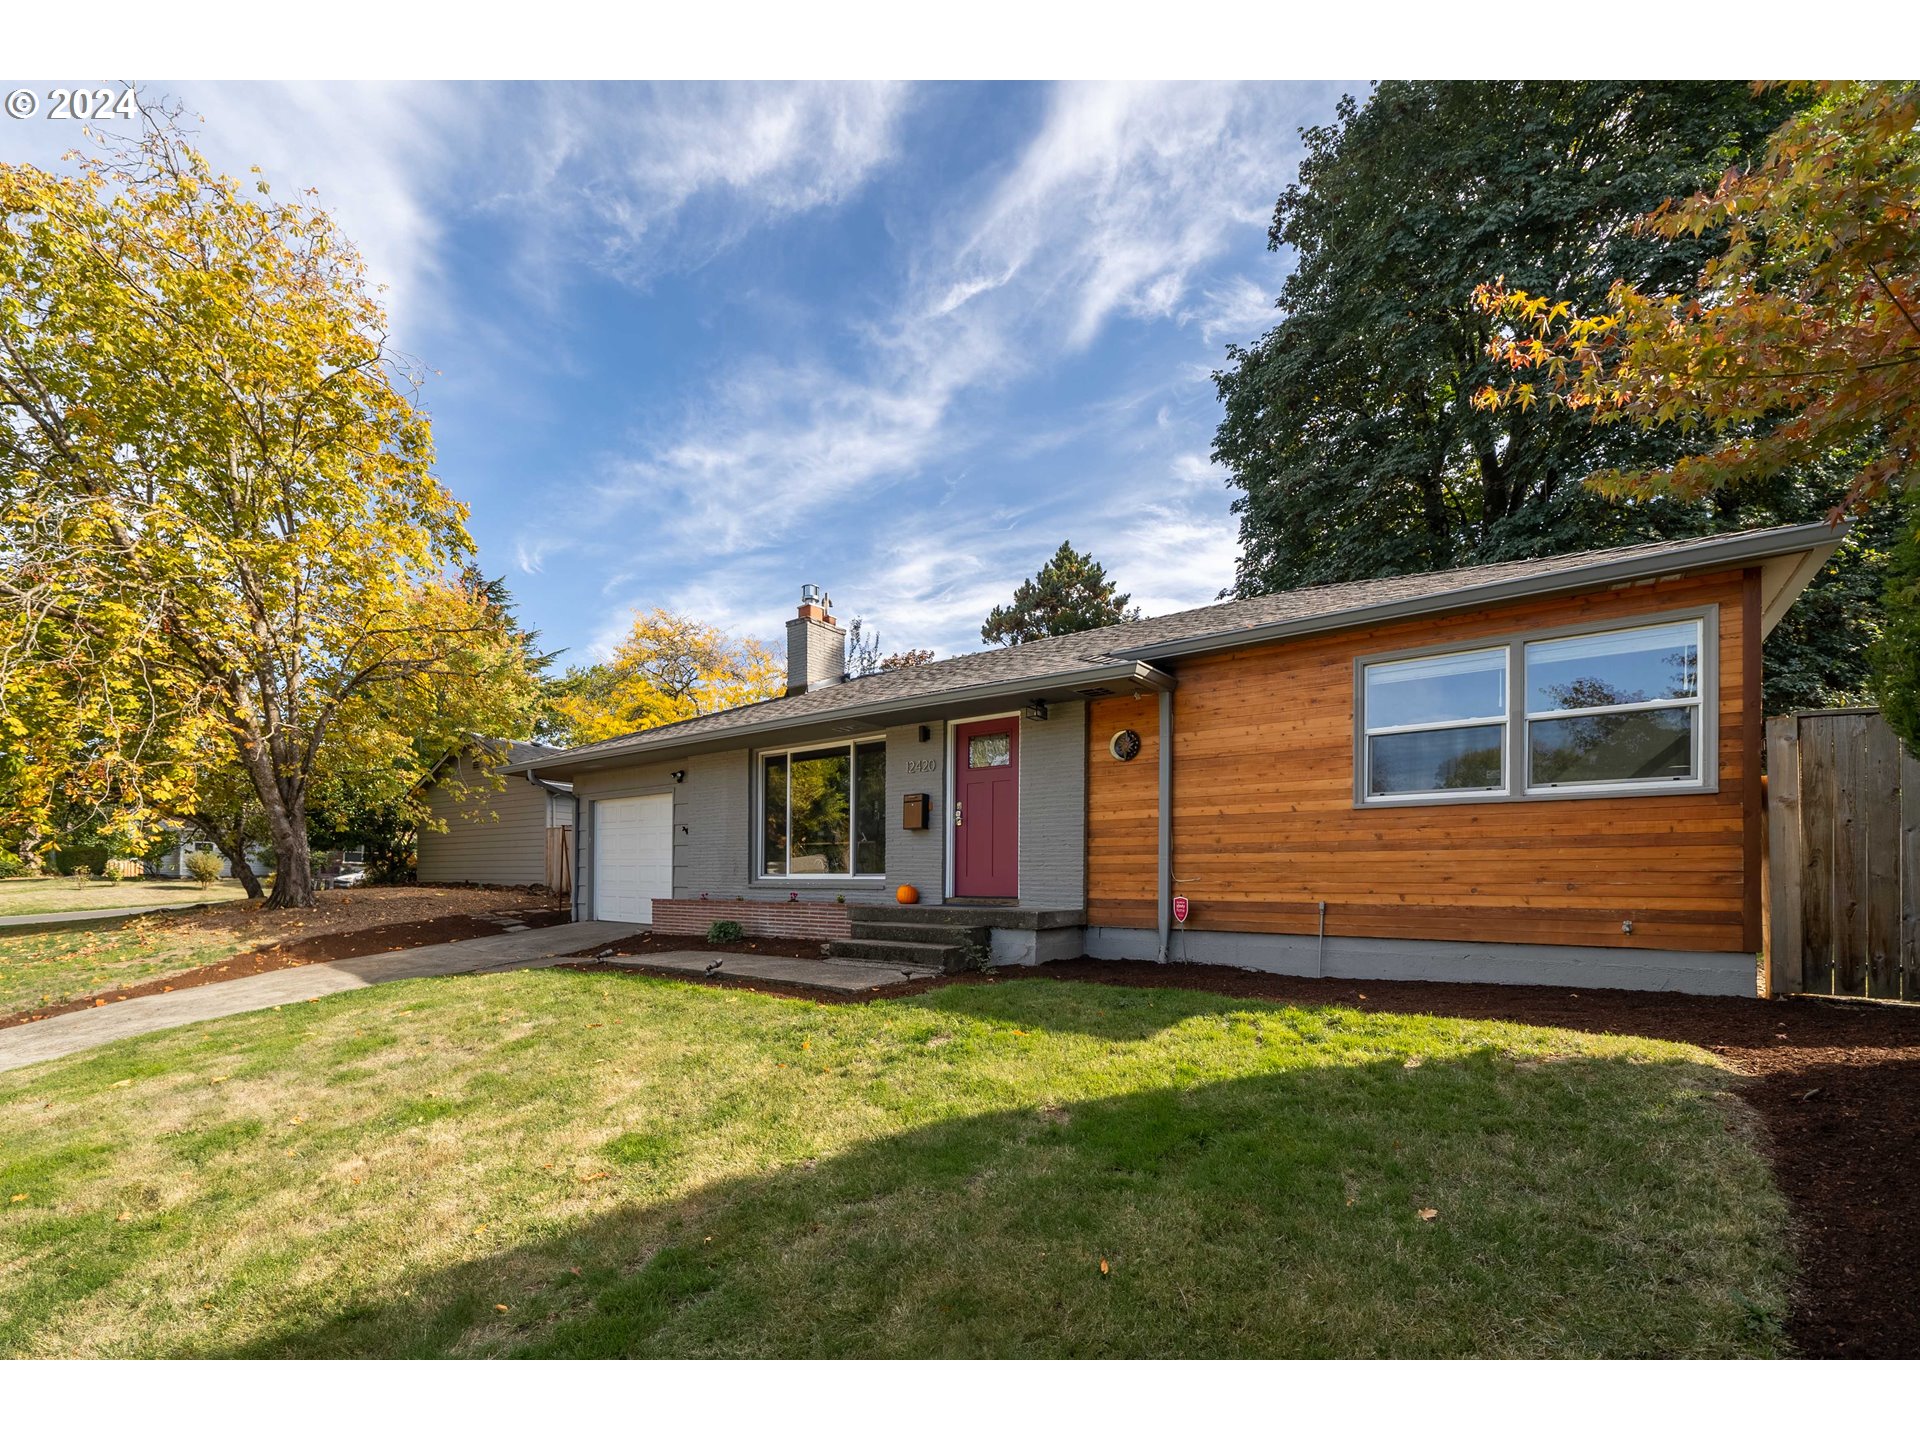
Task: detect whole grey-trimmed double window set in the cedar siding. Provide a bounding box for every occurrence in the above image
[1356,616,1713,801]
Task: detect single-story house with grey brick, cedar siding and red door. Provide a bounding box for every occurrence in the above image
[509,524,1839,995]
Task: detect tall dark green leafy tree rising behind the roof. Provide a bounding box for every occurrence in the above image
[1213,81,1885,705]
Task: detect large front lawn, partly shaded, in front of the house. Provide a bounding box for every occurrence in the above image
[0,970,1788,1356]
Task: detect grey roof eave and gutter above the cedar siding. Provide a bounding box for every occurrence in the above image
[1116,520,1847,660]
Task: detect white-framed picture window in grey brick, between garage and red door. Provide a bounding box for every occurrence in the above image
[760,739,887,879]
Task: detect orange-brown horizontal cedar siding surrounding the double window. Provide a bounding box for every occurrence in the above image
[1087,570,1761,952]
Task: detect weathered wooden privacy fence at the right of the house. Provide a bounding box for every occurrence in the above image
[1766,710,1920,1000]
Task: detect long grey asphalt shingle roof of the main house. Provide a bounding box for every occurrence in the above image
[533,526,1835,762]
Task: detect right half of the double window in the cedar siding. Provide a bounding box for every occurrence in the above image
[1526,618,1705,791]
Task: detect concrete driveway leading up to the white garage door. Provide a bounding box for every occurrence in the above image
[0,920,641,1069]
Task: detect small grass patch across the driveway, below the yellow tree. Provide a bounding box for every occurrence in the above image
[0,920,234,1016]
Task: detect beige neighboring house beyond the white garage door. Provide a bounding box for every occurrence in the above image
[415,739,574,893]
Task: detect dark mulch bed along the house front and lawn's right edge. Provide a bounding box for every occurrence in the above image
[580,960,1920,1359]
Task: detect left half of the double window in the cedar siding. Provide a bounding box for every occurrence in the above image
[1361,645,1511,799]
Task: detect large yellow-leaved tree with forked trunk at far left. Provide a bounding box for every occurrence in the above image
[0,117,538,906]
